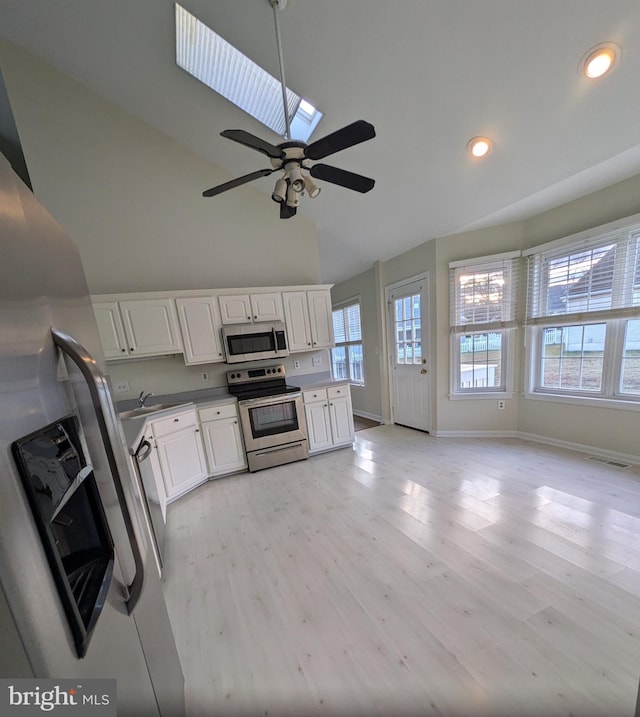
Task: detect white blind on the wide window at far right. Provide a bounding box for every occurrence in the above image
[526,226,640,325]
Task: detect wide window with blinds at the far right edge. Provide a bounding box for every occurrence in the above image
[527,218,640,400]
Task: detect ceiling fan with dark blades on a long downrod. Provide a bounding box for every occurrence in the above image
[202,0,376,219]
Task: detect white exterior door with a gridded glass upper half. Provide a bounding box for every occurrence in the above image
[386,276,431,431]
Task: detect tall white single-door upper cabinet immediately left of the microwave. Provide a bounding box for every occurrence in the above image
[176,296,224,364]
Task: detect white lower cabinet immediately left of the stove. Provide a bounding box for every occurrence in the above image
[198,402,247,476]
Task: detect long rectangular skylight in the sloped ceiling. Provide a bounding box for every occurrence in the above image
[176,3,322,142]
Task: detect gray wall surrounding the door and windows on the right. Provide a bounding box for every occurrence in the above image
[332,175,640,456]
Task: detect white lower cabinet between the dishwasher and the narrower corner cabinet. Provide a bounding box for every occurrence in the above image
[149,408,208,502]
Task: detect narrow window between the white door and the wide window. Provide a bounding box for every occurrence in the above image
[449,252,520,398]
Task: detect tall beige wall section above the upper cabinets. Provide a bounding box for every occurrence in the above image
[0,41,320,293]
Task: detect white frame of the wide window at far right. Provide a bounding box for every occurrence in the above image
[524,214,640,411]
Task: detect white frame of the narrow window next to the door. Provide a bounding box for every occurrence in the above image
[449,251,520,400]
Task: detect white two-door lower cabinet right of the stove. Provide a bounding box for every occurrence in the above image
[302,384,354,453]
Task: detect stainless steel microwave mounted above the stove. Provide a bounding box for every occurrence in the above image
[222,321,289,363]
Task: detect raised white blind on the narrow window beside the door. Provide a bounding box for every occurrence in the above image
[449,252,520,333]
